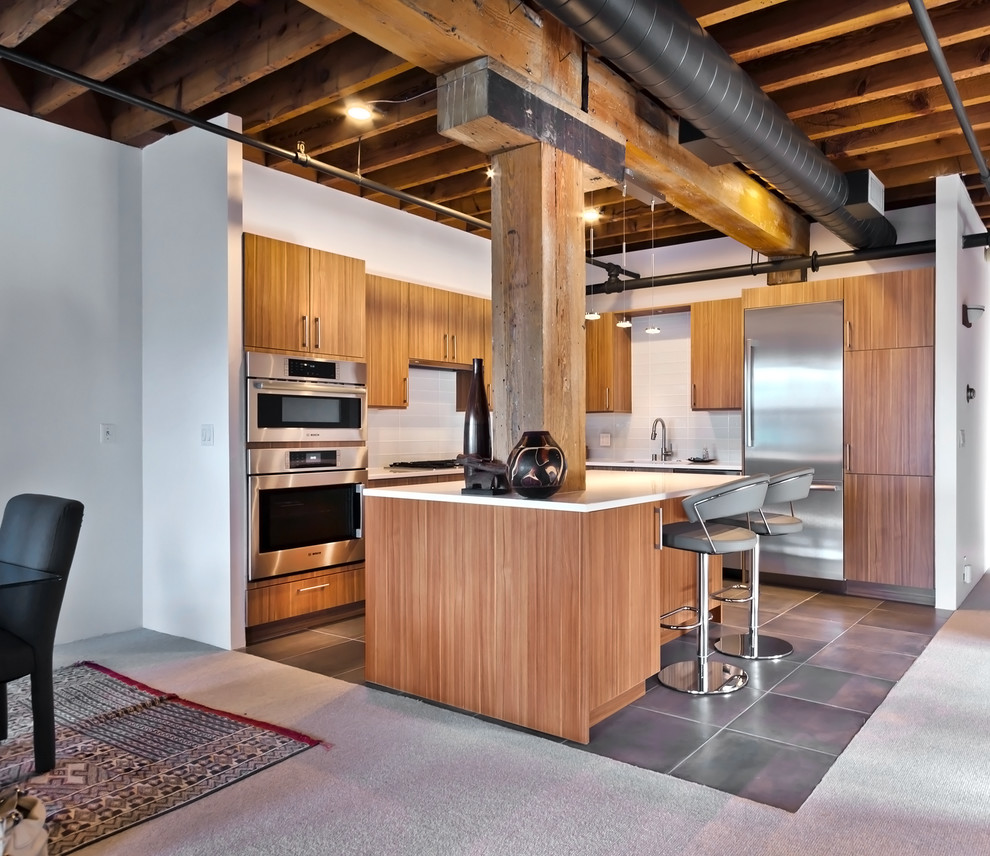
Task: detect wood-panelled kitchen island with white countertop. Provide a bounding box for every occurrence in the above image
[365,471,733,743]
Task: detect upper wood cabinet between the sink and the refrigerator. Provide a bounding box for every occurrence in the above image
[691,297,743,410]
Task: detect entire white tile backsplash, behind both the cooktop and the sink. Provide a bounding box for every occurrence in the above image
[368,312,742,467]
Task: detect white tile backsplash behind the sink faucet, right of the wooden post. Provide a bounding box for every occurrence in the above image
[586,312,742,464]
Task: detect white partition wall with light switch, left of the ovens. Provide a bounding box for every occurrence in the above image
[141,118,247,648]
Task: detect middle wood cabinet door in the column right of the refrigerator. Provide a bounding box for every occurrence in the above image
[844,348,935,482]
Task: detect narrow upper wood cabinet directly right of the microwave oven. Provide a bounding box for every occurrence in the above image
[366,274,410,407]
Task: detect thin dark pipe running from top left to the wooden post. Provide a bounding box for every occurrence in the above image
[0,46,492,234]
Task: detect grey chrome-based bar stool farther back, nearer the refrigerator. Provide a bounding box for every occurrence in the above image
[712,467,815,660]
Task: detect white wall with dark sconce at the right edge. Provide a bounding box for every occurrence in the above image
[935,176,990,609]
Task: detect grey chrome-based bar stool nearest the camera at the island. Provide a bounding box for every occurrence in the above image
[657,475,769,695]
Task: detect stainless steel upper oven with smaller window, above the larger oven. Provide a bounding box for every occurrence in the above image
[247,351,368,444]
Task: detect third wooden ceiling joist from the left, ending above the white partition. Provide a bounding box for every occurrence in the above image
[111,2,347,142]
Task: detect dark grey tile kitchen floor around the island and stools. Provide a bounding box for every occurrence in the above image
[244,585,951,811]
